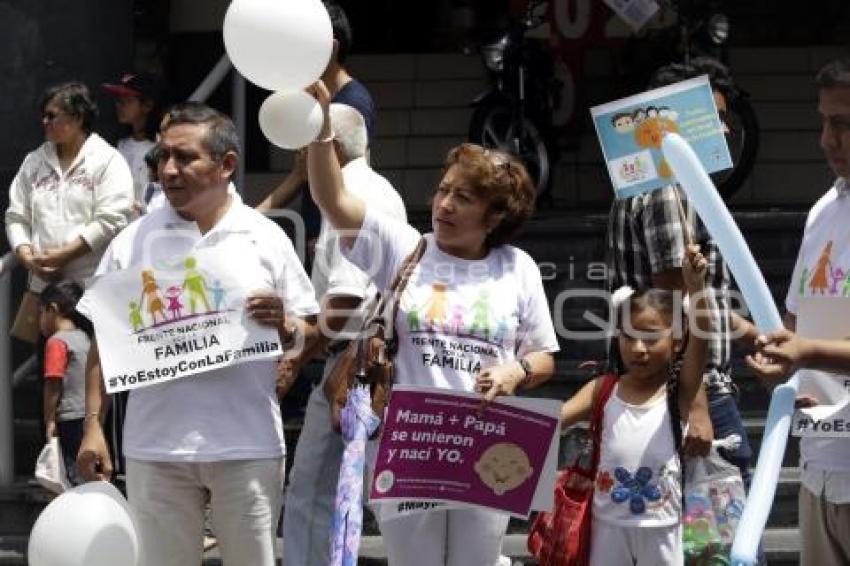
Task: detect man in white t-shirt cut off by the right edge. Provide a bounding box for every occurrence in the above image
[750,57,850,566]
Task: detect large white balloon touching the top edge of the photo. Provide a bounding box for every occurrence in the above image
[223,0,333,91]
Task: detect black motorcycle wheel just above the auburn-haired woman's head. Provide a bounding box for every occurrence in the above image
[469,104,553,196]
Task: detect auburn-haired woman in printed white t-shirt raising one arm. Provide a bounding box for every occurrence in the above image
[308,83,558,566]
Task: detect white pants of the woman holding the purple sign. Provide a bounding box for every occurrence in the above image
[376,509,509,566]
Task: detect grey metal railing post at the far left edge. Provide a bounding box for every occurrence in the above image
[0,252,18,486]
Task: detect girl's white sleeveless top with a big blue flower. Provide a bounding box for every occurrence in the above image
[593,385,682,527]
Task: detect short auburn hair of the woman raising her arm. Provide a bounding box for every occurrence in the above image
[443,143,537,249]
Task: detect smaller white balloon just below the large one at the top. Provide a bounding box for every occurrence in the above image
[259,90,324,149]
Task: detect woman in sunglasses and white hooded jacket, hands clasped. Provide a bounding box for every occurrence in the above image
[6,82,133,292]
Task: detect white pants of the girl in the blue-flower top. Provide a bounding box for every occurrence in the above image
[590,520,685,566]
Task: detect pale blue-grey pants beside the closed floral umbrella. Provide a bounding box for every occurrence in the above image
[283,358,345,566]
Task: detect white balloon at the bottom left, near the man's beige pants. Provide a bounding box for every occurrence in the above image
[27,481,139,566]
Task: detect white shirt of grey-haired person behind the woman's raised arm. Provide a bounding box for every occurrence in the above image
[312,157,407,338]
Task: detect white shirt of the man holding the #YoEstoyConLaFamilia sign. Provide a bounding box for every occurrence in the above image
[78,194,318,462]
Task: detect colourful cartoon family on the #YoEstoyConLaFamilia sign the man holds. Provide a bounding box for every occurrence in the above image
[129,256,226,332]
